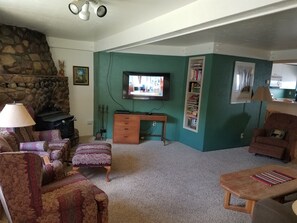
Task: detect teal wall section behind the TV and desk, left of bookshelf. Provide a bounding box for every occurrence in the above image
[94,52,187,141]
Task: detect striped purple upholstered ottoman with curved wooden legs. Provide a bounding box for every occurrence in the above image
[72,143,112,182]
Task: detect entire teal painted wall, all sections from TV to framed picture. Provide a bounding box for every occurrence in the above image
[94,52,272,151]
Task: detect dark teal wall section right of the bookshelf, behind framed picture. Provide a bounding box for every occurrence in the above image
[203,54,272,151]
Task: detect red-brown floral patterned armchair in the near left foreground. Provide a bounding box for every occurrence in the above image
[0,152,108,223]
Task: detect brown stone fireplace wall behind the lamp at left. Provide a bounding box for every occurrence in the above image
[0,24,70,113]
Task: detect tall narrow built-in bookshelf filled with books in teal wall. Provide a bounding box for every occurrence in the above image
[183,57,205,132]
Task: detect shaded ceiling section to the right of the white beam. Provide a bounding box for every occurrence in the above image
[153,9,297,50]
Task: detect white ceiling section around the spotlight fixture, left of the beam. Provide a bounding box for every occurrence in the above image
[0,0,195,41]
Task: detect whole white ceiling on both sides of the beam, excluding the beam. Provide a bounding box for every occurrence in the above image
[0,0,297,50]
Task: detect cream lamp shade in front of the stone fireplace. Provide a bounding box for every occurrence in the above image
[0,103,36,128]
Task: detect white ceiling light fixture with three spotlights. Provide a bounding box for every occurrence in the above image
[68,0,107,21]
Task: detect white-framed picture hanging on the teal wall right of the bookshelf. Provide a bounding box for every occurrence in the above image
[231,61,255,104]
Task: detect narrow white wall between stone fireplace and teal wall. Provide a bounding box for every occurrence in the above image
[48,37,94,136]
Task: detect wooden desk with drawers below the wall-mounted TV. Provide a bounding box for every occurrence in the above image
[113,113,167,145]
